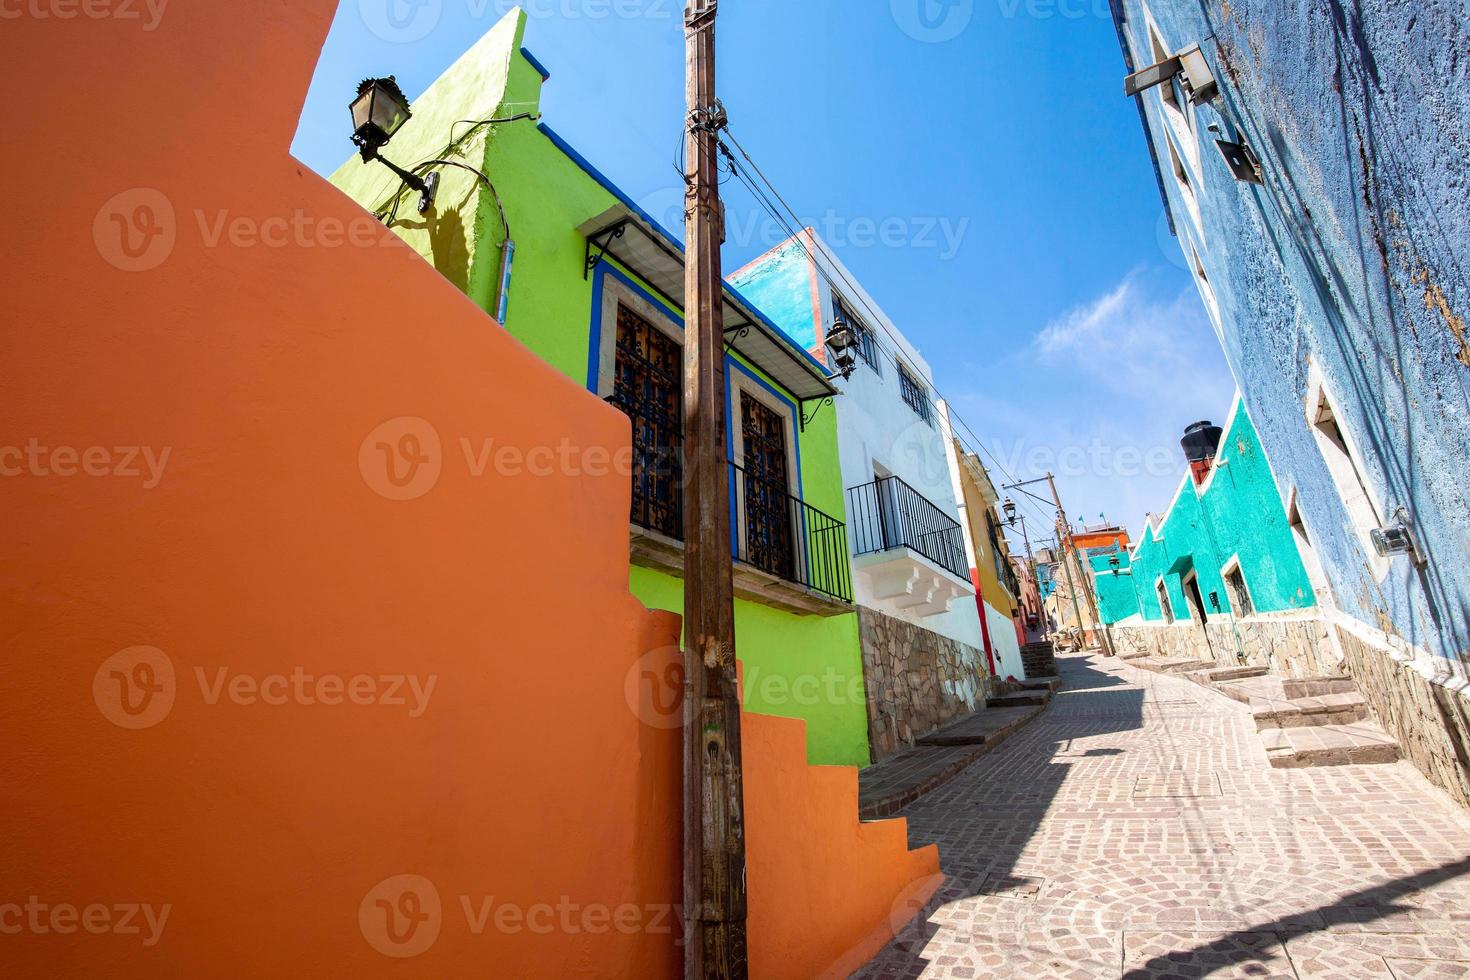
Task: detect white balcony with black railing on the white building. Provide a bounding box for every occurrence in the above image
[847,476,975,619]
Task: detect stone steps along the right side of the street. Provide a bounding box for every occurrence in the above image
[1127,657,1399,768]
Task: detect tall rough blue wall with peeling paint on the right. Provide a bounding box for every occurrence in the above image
[1113,0,1470,671]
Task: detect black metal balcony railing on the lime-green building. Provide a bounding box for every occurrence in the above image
[607,395,853,602]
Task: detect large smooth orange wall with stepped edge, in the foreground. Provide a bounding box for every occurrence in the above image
[0,0,935,977]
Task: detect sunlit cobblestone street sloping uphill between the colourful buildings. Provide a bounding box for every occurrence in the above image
[857,654,1470,980]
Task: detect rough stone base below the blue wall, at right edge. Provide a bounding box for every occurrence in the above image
[1338,629,1470,808]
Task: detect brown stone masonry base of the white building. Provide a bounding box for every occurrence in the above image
[857,605,991,763]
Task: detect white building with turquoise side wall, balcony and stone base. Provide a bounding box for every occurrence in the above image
[731,229,989,761]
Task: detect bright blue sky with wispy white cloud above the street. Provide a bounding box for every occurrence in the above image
[293,0,1235,549]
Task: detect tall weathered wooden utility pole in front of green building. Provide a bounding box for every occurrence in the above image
[684,0,747,980]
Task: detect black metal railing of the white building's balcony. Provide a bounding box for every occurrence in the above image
[847,476,970,580]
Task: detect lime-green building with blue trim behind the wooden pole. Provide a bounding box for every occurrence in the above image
[331,10,869,765]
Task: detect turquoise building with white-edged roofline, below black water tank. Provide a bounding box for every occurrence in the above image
[1091,397,1317,626]
